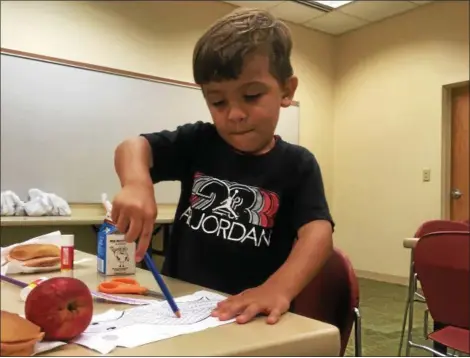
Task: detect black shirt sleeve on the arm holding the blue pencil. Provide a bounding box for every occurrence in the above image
[141,122,207,183]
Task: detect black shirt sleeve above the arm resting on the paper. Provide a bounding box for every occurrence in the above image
[292,151,335,231]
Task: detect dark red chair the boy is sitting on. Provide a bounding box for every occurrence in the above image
[294,248,362,357]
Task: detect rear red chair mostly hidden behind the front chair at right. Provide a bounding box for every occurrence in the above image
[398,220,470,356]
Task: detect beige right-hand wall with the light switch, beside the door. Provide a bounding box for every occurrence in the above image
[333,2,469,276]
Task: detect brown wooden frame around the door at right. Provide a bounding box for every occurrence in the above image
[441,80,470,220]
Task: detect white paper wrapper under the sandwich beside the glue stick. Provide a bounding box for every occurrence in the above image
[0,231,91,275]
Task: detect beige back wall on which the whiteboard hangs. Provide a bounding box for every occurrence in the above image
[1,1,334,260]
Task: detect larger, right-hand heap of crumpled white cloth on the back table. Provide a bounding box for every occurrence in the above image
[24,189,72,216]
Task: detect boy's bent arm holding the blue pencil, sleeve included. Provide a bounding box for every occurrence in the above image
[112,122,206,261]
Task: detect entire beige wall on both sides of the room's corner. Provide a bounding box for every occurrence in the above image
[1,1,468,276]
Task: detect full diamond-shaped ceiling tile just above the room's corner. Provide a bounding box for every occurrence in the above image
[304,11,368,35]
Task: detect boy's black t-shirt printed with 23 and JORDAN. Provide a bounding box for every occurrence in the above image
[143,122,333,294]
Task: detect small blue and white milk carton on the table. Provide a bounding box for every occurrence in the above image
[96,220,136,276]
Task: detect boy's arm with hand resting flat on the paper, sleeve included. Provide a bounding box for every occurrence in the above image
[213,150,334,323]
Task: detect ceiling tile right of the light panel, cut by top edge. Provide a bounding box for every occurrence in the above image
[337,0,418,21]
